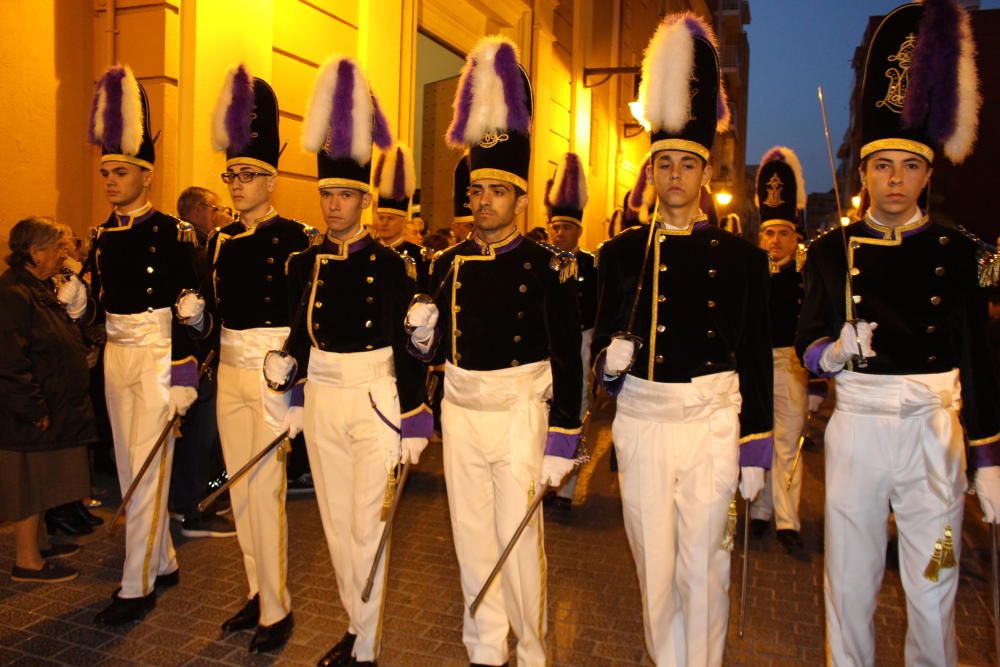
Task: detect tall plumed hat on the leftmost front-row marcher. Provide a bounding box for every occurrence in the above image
[88,65,156,170]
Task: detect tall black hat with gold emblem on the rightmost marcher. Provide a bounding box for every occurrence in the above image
[858,0,982,164]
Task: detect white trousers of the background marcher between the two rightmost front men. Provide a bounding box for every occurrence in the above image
[750,347,809,531]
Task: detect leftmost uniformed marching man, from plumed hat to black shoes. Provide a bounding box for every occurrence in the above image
[90,65,198,625]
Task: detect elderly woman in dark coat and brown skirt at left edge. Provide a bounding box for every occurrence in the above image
[0,218,95,582]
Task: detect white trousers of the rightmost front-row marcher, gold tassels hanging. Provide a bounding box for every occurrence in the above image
[824,371,967,667]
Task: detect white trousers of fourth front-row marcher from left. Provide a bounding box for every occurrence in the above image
[441,361,552,667]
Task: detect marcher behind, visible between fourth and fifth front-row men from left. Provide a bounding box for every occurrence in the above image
[545,153,597,512]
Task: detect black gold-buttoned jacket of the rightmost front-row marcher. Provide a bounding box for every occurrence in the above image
[795,217,1000,465]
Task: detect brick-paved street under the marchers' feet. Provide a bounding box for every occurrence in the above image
[0,400,993,667]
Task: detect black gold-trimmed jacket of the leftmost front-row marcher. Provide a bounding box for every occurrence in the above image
[91,207,198,362]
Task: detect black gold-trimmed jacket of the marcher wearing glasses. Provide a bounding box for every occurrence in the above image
[207,211,318,330]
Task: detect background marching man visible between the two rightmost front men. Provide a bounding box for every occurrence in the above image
[750,146,809,554]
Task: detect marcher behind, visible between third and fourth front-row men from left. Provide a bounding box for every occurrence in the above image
[374,144,429,286]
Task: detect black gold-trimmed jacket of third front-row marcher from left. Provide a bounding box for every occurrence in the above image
[288,230,426,420]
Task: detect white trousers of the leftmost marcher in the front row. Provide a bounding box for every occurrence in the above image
[104,308,177,598]
